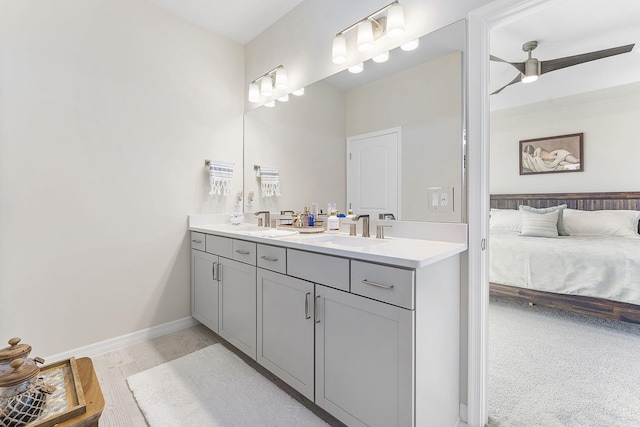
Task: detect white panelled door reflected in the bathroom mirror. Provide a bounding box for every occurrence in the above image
[347,127,401,219]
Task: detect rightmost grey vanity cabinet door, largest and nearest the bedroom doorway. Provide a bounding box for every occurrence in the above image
[315,285,415,427]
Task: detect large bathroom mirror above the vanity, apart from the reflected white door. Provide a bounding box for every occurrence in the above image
[244,21,466,222]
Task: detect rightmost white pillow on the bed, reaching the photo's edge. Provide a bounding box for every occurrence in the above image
[564,209,640,237]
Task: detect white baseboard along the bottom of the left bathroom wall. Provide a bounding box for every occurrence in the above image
[45,316,199,363]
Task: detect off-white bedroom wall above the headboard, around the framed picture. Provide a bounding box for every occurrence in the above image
[490,83,640,194]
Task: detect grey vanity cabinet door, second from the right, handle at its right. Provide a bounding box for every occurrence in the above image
[257,268,314,400]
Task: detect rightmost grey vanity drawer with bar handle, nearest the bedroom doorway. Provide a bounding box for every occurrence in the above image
[351,261,415,309]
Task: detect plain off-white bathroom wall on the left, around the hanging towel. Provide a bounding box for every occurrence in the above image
[0,0,244,356]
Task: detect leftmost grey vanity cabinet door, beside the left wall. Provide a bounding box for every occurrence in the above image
[191,250,219,333]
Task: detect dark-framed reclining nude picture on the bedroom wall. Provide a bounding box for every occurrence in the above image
[520,133,584,175]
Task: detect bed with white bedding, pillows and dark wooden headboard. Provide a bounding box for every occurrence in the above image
[489,192,640,323]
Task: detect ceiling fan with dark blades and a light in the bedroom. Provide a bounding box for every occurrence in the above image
[489,41,635,95]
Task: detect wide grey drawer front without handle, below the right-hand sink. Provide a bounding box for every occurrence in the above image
[287,249,349,292]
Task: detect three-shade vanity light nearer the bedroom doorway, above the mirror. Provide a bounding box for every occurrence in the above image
[331,0,404,67]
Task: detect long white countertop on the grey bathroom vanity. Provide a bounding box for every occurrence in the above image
[189,224,467,268]
